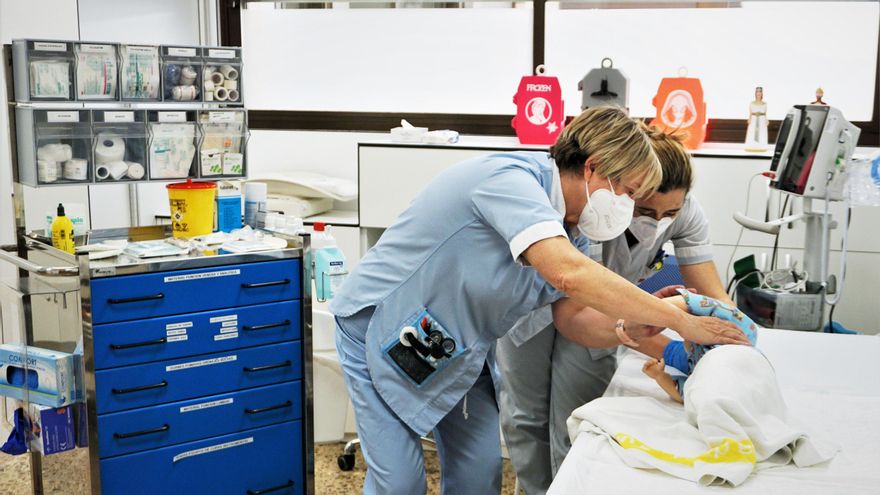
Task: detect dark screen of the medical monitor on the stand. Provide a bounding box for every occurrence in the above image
[777,105,828,194]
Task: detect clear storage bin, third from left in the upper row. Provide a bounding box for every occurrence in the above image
[119,45,162,101]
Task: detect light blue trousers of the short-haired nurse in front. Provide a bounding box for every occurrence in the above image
[336,308,502,495]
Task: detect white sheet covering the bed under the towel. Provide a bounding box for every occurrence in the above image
[548,329,880,495]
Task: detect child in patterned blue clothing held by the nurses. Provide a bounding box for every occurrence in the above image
[642,289,758,403]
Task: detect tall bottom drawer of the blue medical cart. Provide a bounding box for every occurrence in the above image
[101,421,304,495]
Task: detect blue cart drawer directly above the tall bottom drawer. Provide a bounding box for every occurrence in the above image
[98,381,302,458]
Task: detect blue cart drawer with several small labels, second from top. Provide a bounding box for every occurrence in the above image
[94,301,301,369]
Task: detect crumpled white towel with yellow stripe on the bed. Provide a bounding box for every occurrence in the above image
[568,345,838,486]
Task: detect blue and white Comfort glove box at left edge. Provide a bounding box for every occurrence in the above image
[0,344,76,407]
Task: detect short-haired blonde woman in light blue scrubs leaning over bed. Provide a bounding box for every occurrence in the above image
[330,107,748,495]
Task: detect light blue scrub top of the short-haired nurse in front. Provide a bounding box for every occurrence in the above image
[330,152,565,435]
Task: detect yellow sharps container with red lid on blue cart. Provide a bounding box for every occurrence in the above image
[165,179,217,238]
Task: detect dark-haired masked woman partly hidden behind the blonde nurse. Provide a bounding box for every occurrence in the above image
[497,131,733,495]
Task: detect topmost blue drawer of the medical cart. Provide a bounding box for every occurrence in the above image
[92,260,302,324]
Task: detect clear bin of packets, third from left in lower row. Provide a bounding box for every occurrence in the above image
[147,110,199,180]
